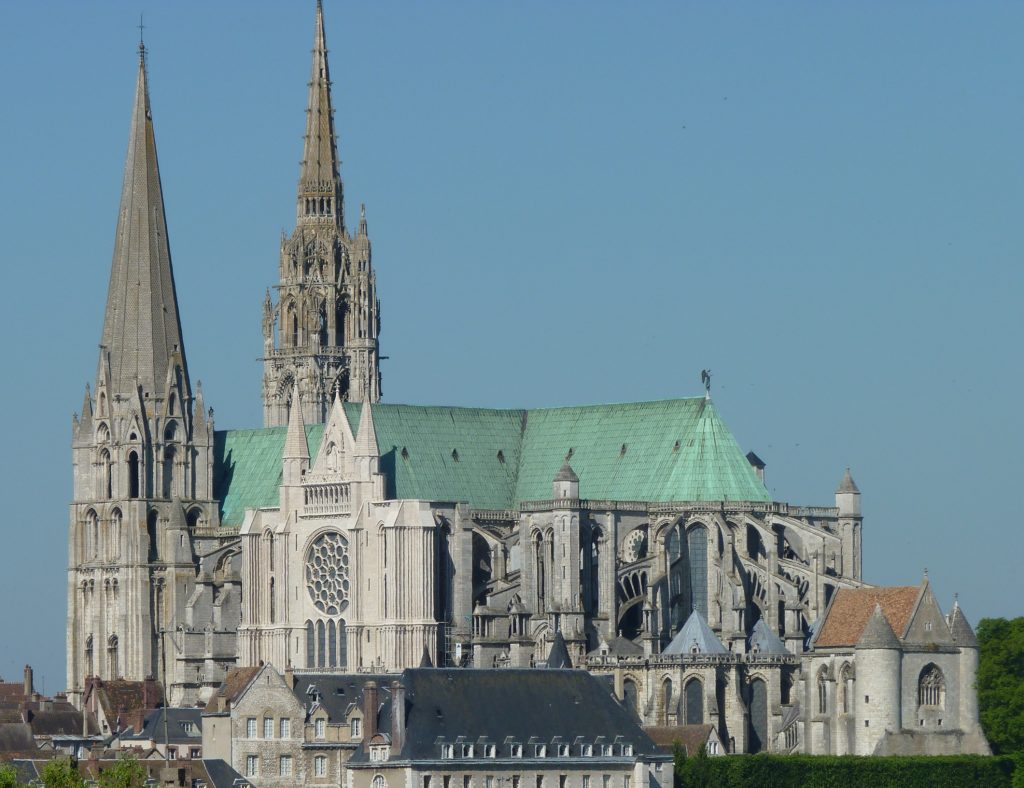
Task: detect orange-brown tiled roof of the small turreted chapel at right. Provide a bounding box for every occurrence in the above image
[813,585,921,648]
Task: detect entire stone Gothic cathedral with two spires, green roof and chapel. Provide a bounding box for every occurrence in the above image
[68,3,987,752]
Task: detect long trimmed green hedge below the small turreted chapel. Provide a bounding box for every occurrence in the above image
[675,753,1024,788]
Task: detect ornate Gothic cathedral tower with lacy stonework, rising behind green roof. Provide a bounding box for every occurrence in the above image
[263,2,381,427]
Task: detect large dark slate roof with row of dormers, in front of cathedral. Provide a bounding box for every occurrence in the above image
[351,668,665,763]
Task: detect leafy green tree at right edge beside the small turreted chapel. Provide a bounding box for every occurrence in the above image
[978,617,1024,754]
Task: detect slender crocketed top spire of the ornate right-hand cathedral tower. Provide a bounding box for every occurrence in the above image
[297,0,345,227]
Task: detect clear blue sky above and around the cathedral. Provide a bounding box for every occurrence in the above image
[0,0,1024,692]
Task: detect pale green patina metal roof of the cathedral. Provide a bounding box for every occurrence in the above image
[214,397,770,525]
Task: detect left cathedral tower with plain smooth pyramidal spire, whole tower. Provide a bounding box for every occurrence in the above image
[68,44,218,701]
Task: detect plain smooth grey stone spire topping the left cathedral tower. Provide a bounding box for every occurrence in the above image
[100,43,188,394]
